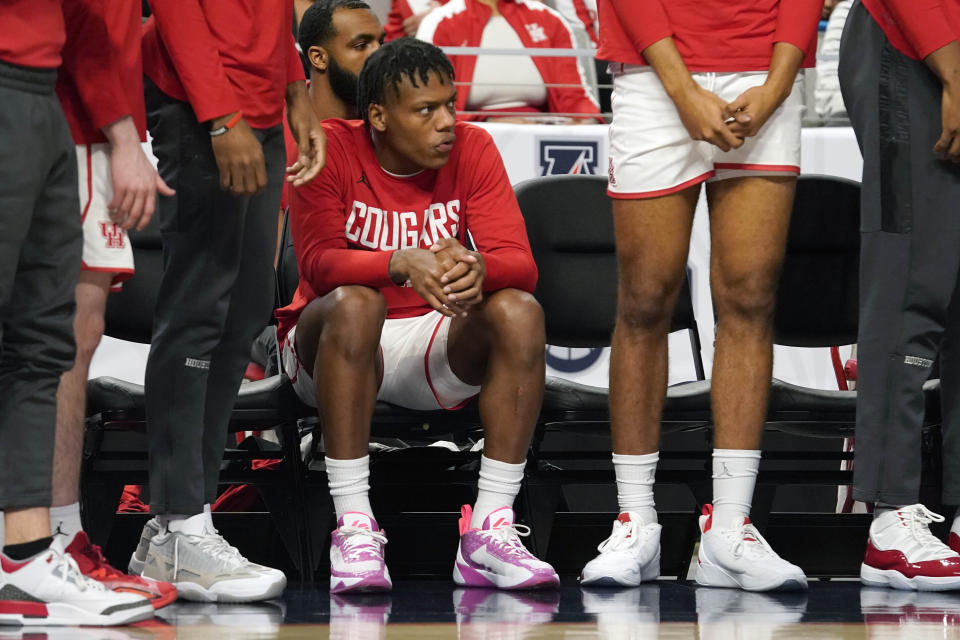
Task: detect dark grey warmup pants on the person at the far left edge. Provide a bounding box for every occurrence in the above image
[0,62,82,509]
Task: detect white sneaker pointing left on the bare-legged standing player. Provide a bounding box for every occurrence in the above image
[580,511,662,587]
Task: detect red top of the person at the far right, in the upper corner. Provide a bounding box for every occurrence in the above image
[863,0,960,60]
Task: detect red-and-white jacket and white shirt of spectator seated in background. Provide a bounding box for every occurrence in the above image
[417,0,602,124]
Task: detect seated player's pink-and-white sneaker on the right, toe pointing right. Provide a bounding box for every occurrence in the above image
[453,505,560,589]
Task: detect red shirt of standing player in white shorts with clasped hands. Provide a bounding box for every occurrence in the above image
[597,0,816,71]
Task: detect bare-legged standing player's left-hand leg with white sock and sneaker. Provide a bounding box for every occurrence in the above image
[580,185,688,586]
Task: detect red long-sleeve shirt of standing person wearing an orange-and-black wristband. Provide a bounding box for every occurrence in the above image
[143,0,303,129]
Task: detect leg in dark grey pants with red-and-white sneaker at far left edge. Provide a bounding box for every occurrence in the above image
[0,71,153,625]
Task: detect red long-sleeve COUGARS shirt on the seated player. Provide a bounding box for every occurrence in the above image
[277,119,537,336]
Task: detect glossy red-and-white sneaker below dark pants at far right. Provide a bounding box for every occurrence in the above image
[860,504,960,591]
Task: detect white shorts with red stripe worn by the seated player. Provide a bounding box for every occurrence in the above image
[280,311,480,411]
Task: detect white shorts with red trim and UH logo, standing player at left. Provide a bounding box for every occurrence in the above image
[77,144,133,290]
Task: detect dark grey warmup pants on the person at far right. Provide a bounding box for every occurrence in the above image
[840,1,960,504]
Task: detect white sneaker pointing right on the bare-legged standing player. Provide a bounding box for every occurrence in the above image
[697,504,807,591]
